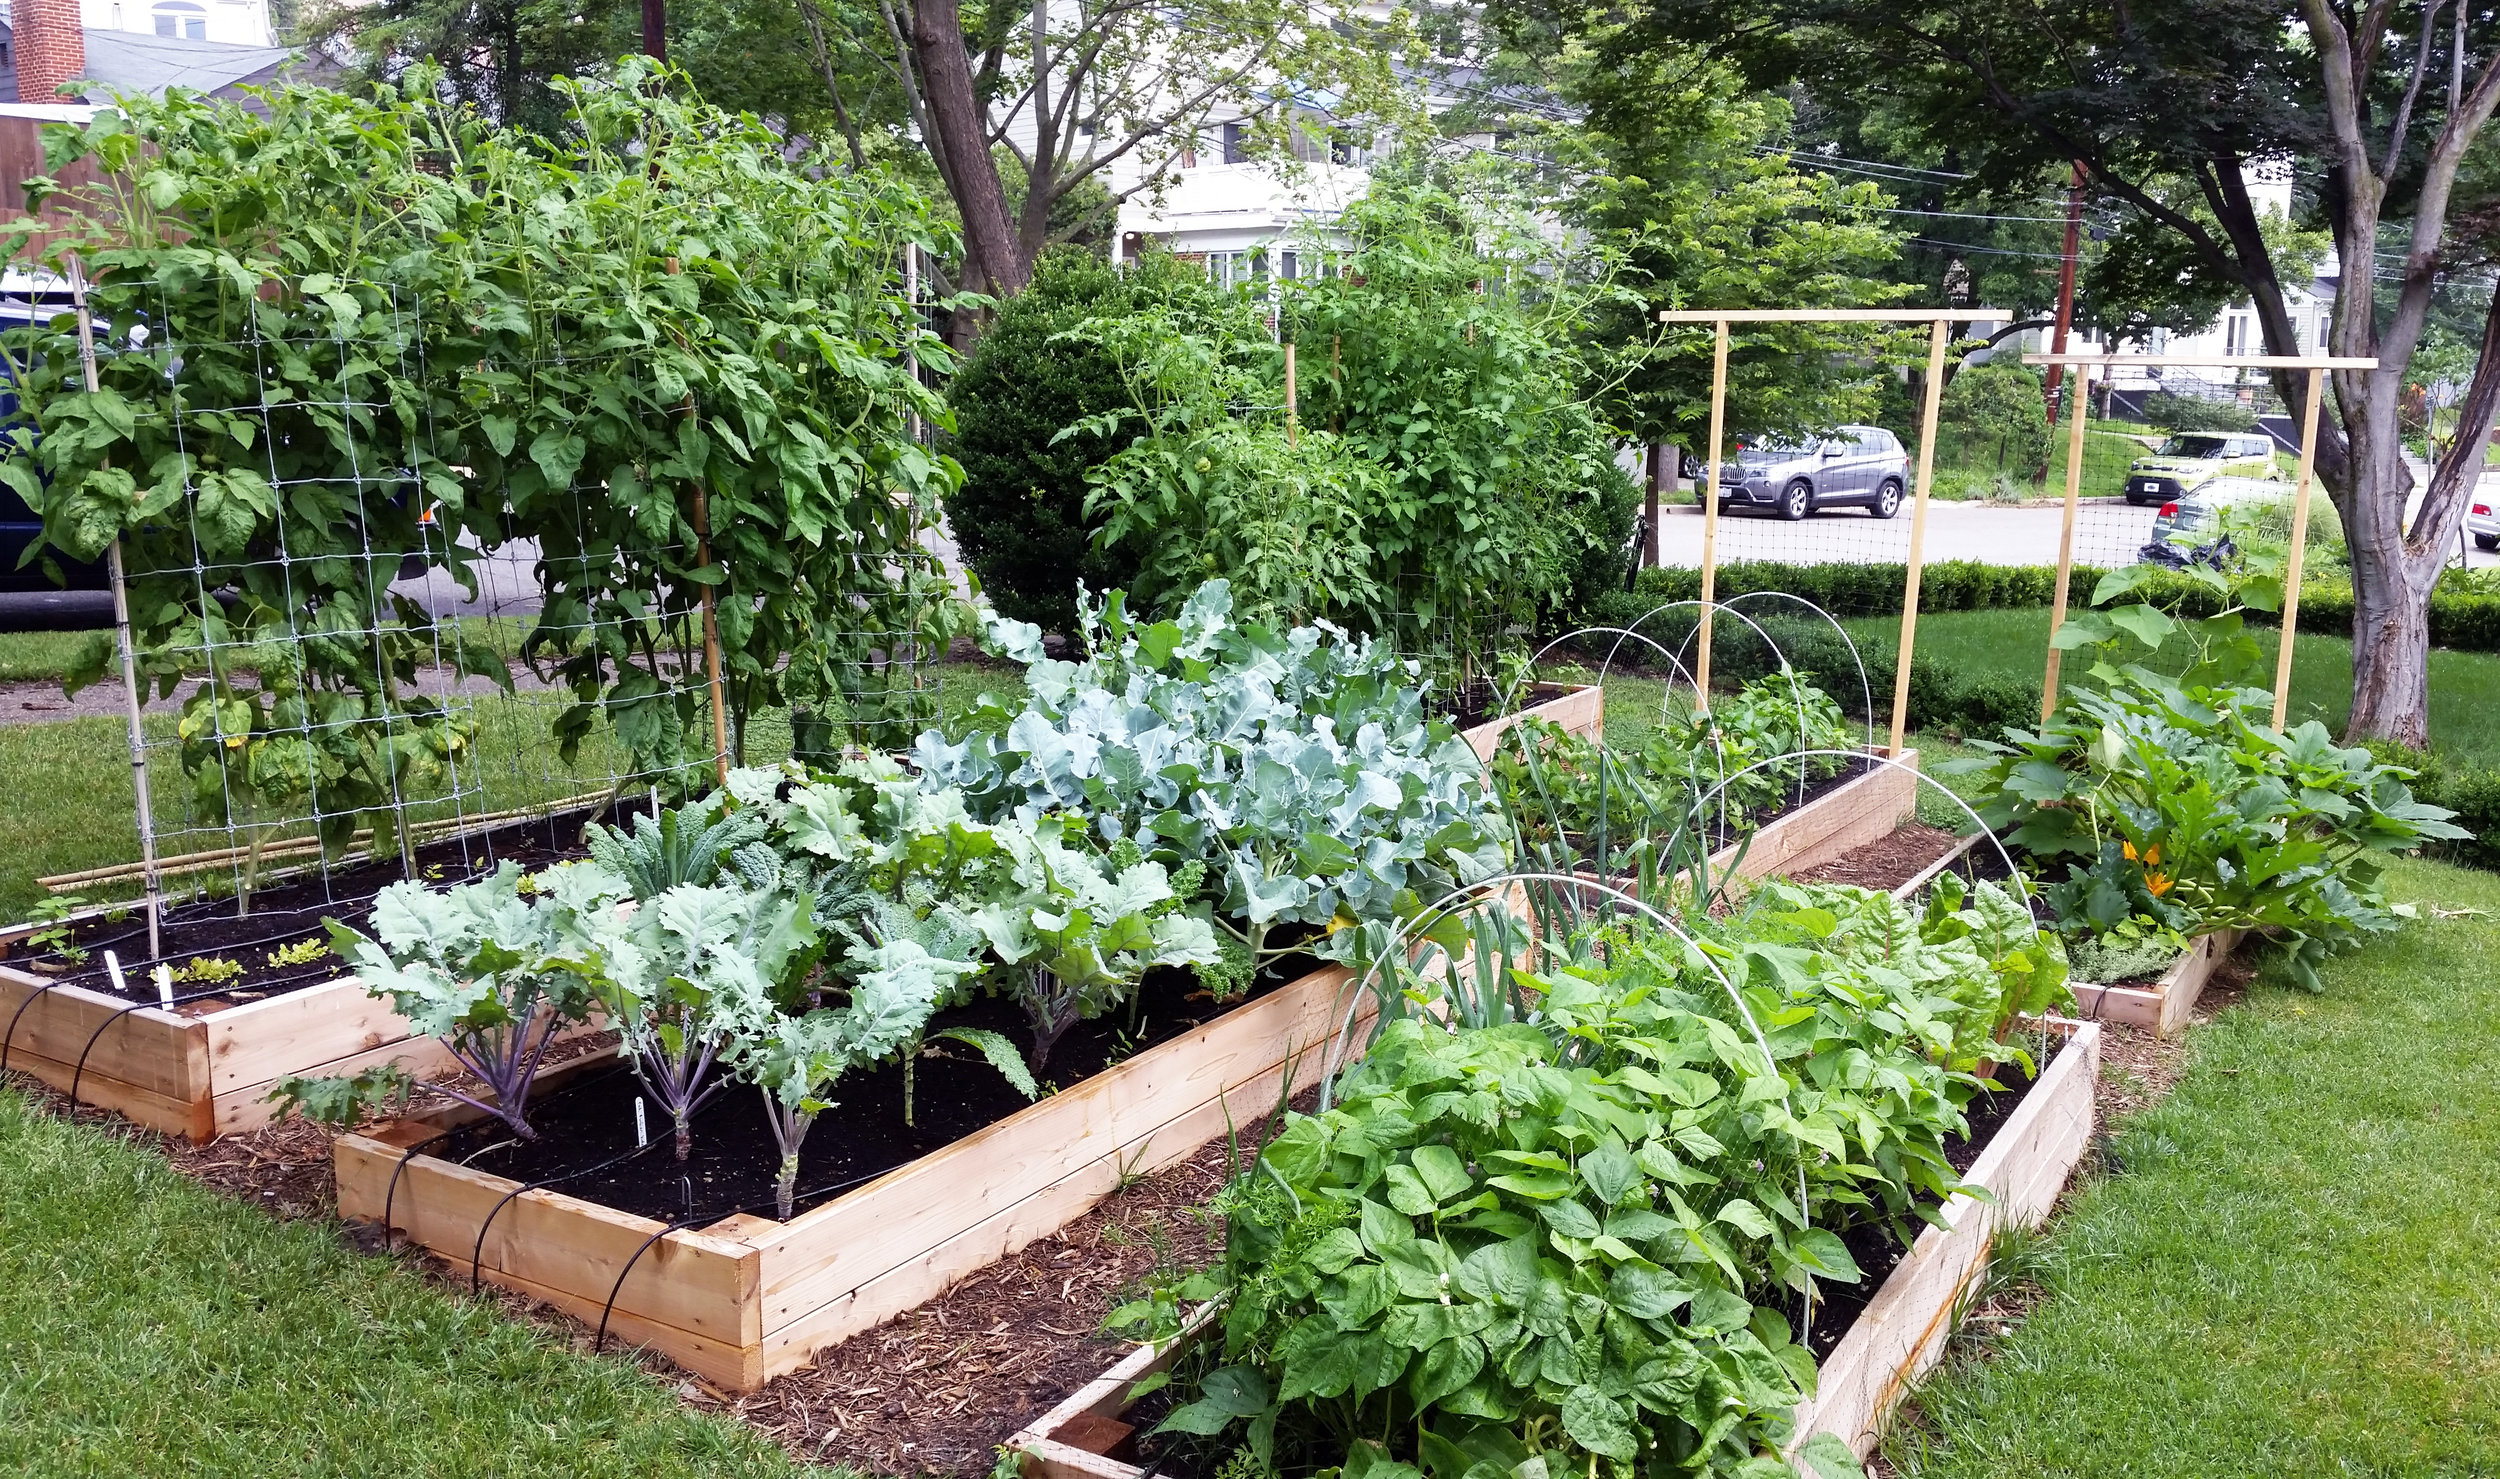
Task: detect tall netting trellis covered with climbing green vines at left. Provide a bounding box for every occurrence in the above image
[0,65,965,924]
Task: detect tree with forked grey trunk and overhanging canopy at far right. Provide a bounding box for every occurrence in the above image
[1610,0,2500,744]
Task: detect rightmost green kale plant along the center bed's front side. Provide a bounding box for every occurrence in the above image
[973,817,1220,1072]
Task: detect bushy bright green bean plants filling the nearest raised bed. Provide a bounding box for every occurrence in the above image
[1140,887,2065,1479]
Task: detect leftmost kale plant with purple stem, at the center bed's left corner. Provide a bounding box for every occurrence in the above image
[290,862,623,1139]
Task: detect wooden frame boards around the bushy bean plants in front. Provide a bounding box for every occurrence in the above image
[1005,1019,2100,1479]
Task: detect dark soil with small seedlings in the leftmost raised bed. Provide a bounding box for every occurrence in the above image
[10,807,625,1014]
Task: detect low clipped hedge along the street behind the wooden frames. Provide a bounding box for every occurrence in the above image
[1588,560,2500,652]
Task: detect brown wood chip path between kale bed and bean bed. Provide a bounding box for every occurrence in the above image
[725,1114,1253,1477]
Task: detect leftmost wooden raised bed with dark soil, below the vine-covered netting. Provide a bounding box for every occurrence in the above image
[0,817,605,1142]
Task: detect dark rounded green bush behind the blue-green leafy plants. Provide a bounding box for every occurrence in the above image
[945,247,1215,632]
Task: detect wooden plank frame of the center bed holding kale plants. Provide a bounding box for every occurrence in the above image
[333,967,1348,1392]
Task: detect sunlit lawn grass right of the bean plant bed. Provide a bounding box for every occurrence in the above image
[1893,862,2500,1479]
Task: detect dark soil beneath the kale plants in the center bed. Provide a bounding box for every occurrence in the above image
[442,957,1318,1222]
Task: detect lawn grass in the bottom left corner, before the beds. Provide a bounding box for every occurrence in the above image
[0,1089,840,1479]
